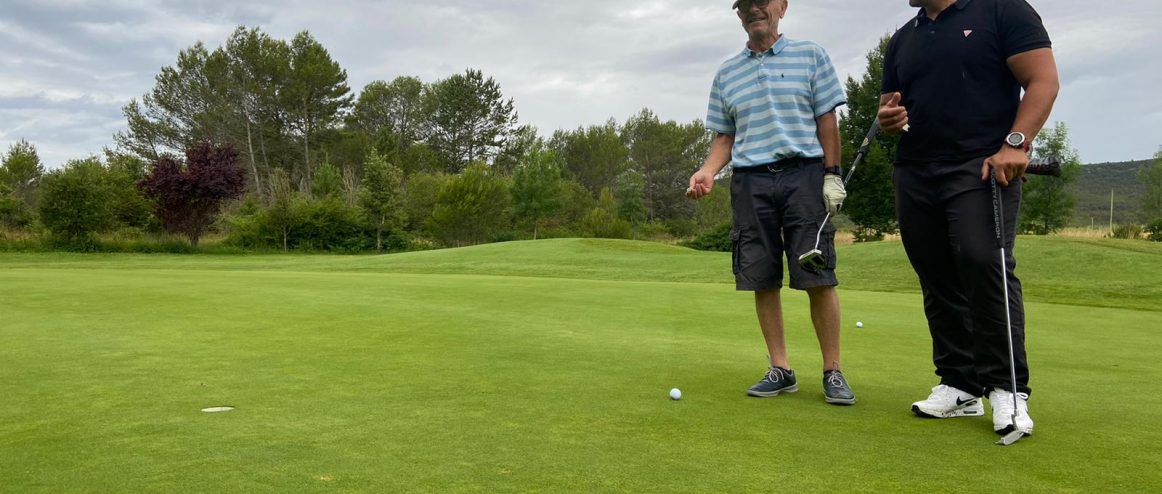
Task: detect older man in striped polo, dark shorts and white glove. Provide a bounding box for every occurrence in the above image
[688,0,855,404]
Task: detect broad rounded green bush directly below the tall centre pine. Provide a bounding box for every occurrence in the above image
[431,163,510,246]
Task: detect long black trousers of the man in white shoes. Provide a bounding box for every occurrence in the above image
[892,158,1030,396]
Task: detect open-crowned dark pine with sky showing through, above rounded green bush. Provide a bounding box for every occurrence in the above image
[429,69,517,173]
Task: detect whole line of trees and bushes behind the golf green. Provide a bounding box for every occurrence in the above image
[0,27,1162,251]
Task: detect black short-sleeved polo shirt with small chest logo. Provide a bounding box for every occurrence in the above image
[882,0,1052,164]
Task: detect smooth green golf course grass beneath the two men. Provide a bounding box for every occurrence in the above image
[0,237,1162,493]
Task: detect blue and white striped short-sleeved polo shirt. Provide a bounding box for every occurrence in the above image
[706,36,847,167]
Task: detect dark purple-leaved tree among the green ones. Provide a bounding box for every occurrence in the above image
[138,143,246,246]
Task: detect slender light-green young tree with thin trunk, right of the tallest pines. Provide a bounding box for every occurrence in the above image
[359,152,406,253]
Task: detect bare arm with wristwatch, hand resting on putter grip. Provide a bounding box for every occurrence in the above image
[981,48,1061,186]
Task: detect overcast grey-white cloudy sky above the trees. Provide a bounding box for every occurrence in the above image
[0,0,1162,167]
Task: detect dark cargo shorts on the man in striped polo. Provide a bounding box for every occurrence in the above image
[730,158,839,292]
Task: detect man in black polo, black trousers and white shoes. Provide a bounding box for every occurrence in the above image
[878,0,1059,434]
